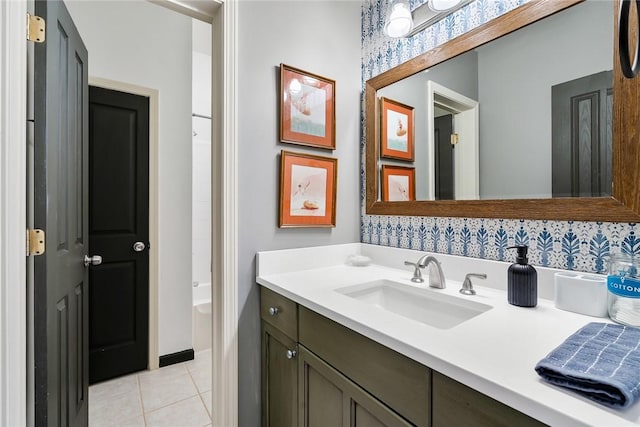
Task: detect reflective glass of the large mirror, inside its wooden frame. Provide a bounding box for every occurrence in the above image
[377,0,613,201]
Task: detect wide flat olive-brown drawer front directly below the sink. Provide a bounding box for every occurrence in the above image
[298,306,431,426]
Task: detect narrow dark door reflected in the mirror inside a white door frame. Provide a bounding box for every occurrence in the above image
[433,114,455,200]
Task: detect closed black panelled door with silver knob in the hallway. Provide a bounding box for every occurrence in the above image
[89,86,149,384]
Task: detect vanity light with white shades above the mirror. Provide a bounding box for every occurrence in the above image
[384,0,473,38]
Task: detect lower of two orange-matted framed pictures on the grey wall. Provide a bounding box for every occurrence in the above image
[278,150,338,228]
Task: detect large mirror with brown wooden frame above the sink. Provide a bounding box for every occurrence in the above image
[366,0,640,222]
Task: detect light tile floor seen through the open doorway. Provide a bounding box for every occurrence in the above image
[89,350,211,427]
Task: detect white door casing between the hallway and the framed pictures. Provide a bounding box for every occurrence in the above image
[211,0,238,427]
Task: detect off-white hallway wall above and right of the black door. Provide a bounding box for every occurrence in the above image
[65,0,192,355]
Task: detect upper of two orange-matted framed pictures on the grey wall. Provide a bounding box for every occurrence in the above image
[280,64,336,150]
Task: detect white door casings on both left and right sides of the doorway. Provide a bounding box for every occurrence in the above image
[0,0,238,427]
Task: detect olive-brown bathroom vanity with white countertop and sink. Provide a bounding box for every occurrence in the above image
[257,244,640,426]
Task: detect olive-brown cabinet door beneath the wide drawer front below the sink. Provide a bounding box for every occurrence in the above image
[298,346,412,427]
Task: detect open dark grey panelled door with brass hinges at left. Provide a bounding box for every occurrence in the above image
[33,1,89,426]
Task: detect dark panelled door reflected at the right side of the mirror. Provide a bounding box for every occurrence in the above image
[551,71,613,197]
